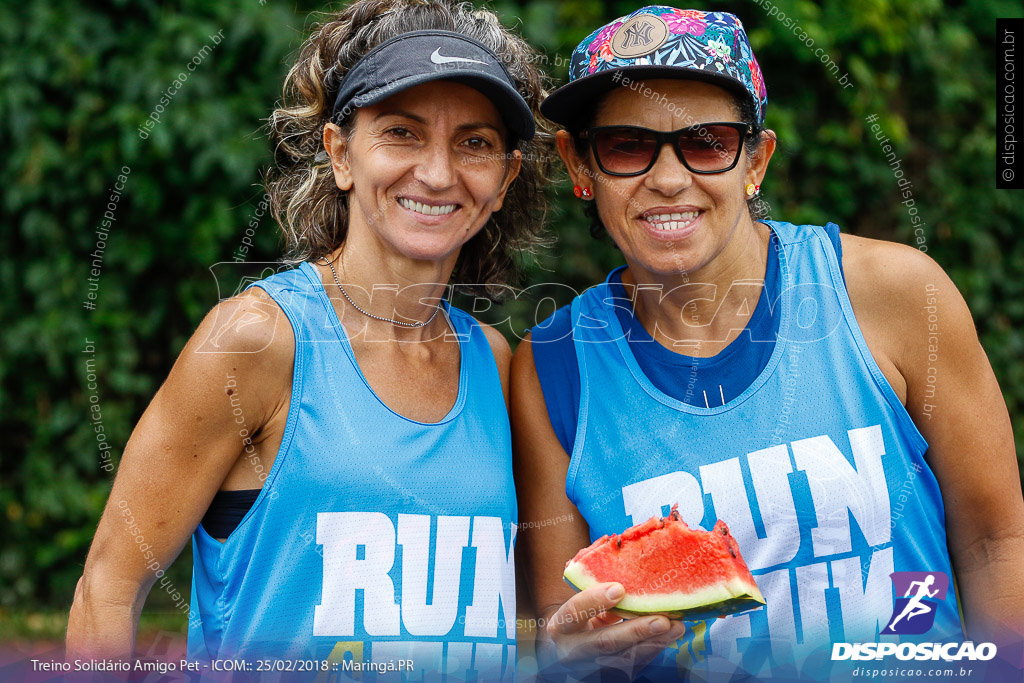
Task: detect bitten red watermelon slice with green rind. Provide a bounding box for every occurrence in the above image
[562,505,765,621]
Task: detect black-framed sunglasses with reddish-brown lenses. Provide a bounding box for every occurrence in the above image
[580,121,754,176]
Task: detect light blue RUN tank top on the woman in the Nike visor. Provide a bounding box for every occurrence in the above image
[188,263,517,681]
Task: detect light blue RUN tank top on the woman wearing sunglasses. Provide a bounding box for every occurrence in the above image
[565,221,963,681]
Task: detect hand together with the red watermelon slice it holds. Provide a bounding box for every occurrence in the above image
[538,506,765,680]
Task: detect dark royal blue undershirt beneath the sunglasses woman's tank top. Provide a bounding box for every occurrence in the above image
[530,223,843,453]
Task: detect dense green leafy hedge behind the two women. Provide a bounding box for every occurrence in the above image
[0,0,1024,639]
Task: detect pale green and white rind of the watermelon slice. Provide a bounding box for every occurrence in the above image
[562,562,766,622]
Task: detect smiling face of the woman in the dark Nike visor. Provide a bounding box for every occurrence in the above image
[325,81,521,264]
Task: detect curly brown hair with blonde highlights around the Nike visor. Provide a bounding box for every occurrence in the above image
[264,0,553,299]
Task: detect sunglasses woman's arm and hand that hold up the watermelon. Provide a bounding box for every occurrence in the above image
[512,336,684,677]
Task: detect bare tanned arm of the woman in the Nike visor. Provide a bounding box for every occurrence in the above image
[67,288,294,658]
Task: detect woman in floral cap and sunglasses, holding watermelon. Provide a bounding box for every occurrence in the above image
[512,6,1024,680]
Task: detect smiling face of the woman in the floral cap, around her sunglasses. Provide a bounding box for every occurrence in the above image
[558,79,774,274]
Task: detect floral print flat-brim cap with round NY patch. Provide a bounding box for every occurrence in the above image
[541,5,768,127]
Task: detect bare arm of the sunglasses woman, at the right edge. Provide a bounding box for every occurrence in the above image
[844,239,1024,644]
